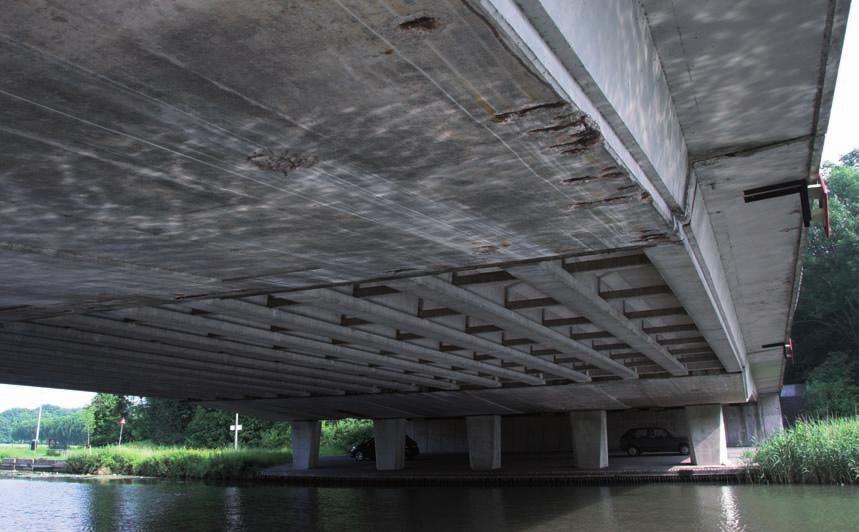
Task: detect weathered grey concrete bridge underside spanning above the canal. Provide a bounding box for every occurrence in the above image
[0,0,849,467]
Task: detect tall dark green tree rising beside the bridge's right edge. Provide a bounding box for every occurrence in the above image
[787,150,859,382]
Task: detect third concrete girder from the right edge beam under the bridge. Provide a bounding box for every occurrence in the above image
[288,289,581,384]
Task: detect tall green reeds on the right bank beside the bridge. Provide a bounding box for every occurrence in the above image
[753,416,859,484]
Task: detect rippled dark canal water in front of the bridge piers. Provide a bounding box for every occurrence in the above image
[0,478,859,532]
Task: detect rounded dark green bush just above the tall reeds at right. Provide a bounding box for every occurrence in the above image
[806,352,859,417]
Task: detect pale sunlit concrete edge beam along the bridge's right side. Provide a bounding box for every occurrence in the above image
[482,0,757,394]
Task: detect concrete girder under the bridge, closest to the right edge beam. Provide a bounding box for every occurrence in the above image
[509,261,689,376]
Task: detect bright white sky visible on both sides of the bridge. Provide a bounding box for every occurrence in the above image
[0,6,859,412]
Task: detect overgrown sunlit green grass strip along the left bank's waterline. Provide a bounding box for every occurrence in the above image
[66,446,292,480]
